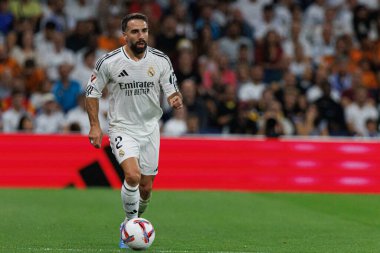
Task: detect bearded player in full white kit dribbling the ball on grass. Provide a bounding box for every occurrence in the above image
[86,13,183,247]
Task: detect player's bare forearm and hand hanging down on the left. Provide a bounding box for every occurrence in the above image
[86,97,103,148]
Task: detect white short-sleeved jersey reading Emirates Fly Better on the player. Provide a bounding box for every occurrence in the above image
[86,47,178,136]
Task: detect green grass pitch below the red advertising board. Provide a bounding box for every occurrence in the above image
[0,189,380,253]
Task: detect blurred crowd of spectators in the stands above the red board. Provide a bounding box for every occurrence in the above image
[0,0,380,137]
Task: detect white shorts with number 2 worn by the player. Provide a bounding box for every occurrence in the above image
[109,127,160,176]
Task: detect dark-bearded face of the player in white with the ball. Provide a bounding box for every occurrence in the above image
[124,19,148,54]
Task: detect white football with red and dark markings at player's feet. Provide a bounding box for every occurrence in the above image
[121,218,156,250]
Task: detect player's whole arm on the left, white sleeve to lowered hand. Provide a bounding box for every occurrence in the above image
[86,61,108,148]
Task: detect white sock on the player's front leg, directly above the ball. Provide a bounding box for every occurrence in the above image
[121,180,140,220]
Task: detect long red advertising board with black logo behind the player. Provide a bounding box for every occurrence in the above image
[0,135,380,193]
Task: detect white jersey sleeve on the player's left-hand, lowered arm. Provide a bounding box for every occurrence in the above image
[86,59,109,98]
